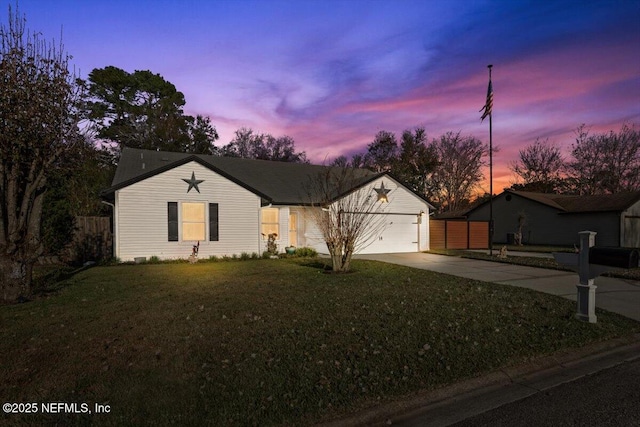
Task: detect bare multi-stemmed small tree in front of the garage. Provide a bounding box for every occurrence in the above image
[306,168,388,273]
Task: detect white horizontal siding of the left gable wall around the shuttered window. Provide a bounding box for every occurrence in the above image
[115,162,261,261]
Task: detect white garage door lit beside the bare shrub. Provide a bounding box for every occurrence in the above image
[359,214,418,254]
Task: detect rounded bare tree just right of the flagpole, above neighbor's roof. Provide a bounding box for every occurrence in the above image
[509,138,565,193]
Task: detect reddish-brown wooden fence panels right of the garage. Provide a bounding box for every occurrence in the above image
[429,219,489,249]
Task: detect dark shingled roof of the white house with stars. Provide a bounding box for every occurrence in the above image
[103,148,402,205]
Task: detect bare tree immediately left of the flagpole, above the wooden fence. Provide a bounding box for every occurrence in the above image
[429,132,488,211]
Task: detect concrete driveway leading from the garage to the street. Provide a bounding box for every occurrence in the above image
[356,253,640,321]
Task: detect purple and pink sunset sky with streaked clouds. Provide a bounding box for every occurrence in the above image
[10,0,640,193]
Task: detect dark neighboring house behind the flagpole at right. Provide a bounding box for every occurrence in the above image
[466,190,640,248]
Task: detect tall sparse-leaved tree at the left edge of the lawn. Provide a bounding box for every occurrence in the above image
[0,8,80,301]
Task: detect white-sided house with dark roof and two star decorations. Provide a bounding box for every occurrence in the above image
[103,148,433,261]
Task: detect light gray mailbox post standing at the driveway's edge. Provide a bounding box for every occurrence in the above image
[576,231,598,323]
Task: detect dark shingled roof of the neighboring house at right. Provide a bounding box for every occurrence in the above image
[507,190,640,213]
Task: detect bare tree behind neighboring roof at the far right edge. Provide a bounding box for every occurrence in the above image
[569,124,640,194]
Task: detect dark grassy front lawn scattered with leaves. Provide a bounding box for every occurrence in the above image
[0,259,640,426]
